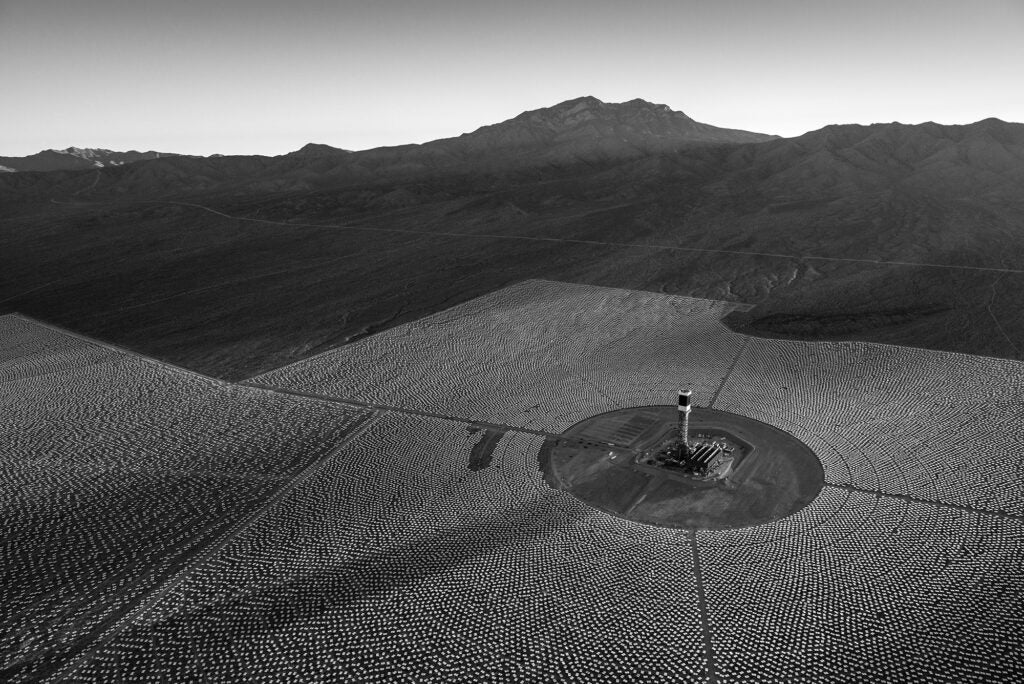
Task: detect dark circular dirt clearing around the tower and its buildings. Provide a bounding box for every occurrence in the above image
[539,405,824,529]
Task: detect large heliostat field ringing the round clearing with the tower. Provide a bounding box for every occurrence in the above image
[2,281,1024,682]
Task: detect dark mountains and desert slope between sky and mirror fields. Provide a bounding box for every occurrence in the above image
[0,97,1024,377]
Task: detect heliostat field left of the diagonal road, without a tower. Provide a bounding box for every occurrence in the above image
[0,315,367,681]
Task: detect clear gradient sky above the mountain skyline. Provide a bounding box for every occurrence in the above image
[0,0,1024,156]
